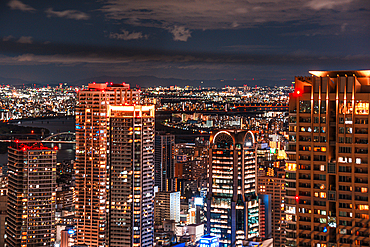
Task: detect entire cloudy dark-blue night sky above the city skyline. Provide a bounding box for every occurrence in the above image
[0,0,370,86]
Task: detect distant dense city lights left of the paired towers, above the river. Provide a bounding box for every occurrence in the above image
[0,84,76,121]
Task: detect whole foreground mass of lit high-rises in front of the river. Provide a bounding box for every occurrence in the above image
[0,71,370,247]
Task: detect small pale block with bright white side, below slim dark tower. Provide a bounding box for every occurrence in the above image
[154,191,181,225]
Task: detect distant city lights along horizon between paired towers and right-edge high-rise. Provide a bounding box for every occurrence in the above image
[142,85,293,112]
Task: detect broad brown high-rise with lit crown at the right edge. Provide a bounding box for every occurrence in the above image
[287,71,370,247]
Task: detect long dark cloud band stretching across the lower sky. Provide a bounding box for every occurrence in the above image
[0,41,370,69]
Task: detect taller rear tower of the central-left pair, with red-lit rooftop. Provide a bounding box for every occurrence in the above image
[75,83,139,247]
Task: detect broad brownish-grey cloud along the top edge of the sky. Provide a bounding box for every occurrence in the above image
[101,0,367,30]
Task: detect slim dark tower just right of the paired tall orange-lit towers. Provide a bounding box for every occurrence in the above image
[154,132,175,191]
